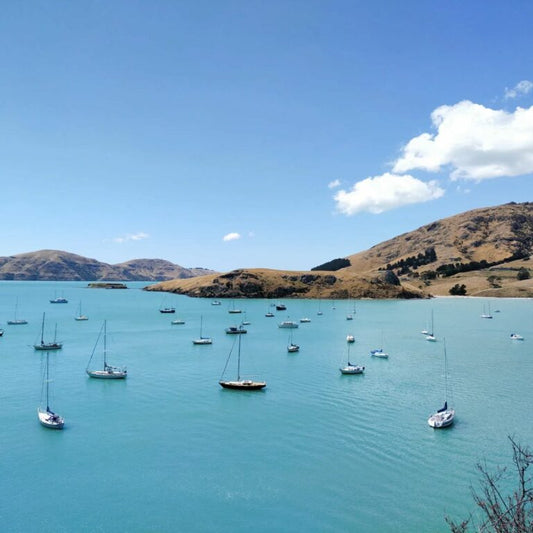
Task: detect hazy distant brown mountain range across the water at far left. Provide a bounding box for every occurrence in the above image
[0,250,213,281]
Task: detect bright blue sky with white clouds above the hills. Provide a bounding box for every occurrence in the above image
[0,0,533,271]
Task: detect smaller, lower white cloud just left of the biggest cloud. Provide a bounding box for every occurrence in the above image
[335,172,444,215]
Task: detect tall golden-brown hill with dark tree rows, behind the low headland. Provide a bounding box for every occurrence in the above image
[330,202,533,297]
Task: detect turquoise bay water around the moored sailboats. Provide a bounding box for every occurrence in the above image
[0,282,533,532]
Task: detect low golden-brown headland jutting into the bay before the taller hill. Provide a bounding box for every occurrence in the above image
[142,269,423,299]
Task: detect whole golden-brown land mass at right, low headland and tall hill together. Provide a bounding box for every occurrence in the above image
[147,202,533,299]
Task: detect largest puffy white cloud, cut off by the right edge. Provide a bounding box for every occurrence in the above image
[393,100,533,181]
